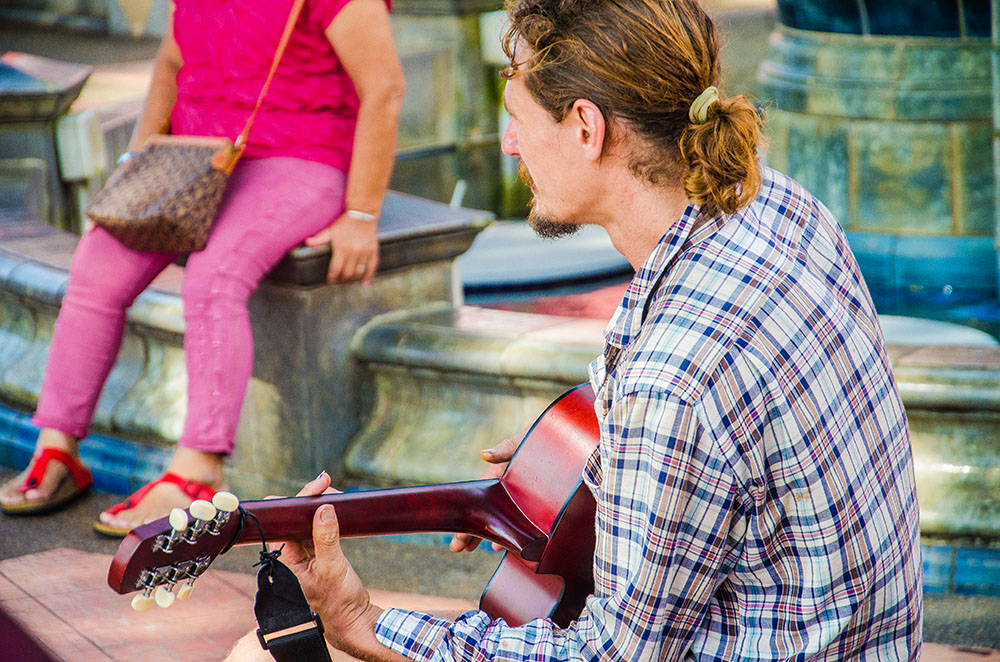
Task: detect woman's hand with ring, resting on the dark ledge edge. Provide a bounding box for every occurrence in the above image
[306,212,378,285]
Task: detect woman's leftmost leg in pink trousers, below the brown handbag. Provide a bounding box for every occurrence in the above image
[0,228,175,504]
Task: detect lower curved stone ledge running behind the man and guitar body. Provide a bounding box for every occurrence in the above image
[346,306,1000,540]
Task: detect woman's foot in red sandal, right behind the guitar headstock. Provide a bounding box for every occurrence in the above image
[94,448,225,536]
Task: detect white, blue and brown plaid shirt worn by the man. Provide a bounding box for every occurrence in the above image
[376,170,922,662]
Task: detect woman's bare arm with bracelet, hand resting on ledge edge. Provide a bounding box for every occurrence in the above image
[306,0,405,283]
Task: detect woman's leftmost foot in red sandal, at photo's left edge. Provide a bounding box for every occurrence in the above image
[0,428,93,515]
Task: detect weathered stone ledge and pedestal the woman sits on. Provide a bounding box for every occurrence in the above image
[0,194,490,496]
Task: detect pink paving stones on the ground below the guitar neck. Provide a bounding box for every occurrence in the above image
[0,549,474,662]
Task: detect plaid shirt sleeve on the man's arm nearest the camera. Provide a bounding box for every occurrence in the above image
[375,394,738,662]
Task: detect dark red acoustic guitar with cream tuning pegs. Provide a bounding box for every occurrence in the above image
[108,385,600,626]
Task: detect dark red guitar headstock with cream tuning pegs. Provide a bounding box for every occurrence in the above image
[108,492,242,611]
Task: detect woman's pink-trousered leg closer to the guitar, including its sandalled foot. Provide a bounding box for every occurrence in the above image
[101,157,345,526]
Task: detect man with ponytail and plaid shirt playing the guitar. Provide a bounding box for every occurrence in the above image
[223,0,922,662]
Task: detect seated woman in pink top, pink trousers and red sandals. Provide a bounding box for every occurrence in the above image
[0,0,404,536]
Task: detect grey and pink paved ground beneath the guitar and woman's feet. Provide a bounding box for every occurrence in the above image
[0,468,500,662]
